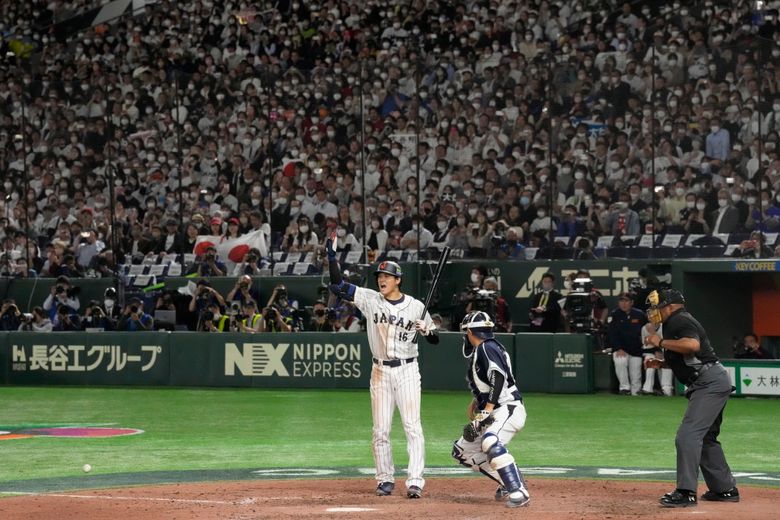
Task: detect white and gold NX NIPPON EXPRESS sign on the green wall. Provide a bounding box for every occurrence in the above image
[225,342,363,379]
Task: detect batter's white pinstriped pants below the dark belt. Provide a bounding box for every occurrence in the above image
[370,361,425,489]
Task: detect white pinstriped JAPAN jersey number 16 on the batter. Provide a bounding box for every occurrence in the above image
[353,287,433,359]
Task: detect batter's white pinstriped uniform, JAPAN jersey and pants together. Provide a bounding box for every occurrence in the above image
[354,287,434,488]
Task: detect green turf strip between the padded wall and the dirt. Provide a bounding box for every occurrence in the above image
[0,387,780,482]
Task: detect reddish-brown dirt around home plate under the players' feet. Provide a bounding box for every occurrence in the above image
[0,478,780,520]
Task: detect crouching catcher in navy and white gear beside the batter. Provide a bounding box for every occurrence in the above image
[452,311,531,507]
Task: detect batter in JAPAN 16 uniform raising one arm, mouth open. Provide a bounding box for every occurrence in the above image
[325,234,439,498]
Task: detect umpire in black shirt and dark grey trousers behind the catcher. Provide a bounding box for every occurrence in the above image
[645,289,739,507]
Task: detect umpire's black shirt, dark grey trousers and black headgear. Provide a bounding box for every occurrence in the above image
[659,290,736,504]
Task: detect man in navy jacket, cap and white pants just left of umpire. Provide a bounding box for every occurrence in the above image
[607,292,647,395]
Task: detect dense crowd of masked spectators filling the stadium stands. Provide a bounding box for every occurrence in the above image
[0,0,780,278]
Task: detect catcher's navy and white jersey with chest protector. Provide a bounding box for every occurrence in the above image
[467,339,521,409]
